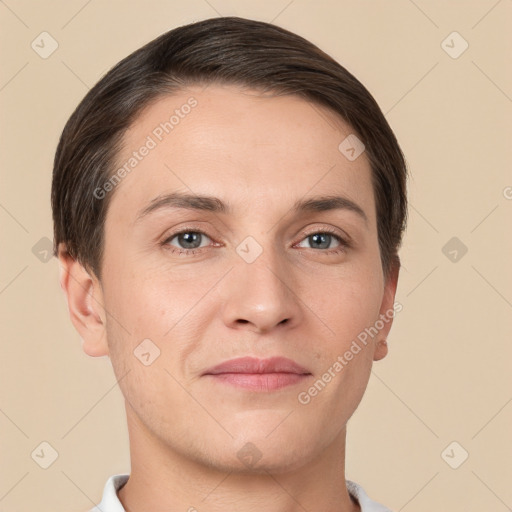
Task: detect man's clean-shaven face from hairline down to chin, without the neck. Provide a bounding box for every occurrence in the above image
[66,86,396,471]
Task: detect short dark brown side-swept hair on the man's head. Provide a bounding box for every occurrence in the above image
[51,17,407,279]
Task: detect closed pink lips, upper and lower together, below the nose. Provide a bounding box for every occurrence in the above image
[203,357,311,392]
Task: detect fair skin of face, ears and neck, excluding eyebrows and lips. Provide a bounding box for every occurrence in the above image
[59,85,398,512]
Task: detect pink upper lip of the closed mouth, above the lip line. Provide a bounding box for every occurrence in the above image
[203,357,310,375]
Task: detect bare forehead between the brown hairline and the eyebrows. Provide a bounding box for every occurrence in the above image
[111,85,374,224]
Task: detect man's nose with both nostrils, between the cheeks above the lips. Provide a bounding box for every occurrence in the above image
[222,245,301,334]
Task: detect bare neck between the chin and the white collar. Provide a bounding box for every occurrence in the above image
[118,404,360,512]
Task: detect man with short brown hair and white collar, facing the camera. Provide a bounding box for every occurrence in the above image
[52,17,406,512]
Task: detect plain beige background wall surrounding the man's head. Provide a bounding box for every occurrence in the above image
[0,0,512,512]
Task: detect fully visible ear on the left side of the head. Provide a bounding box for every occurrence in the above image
[58,243,109,357]
